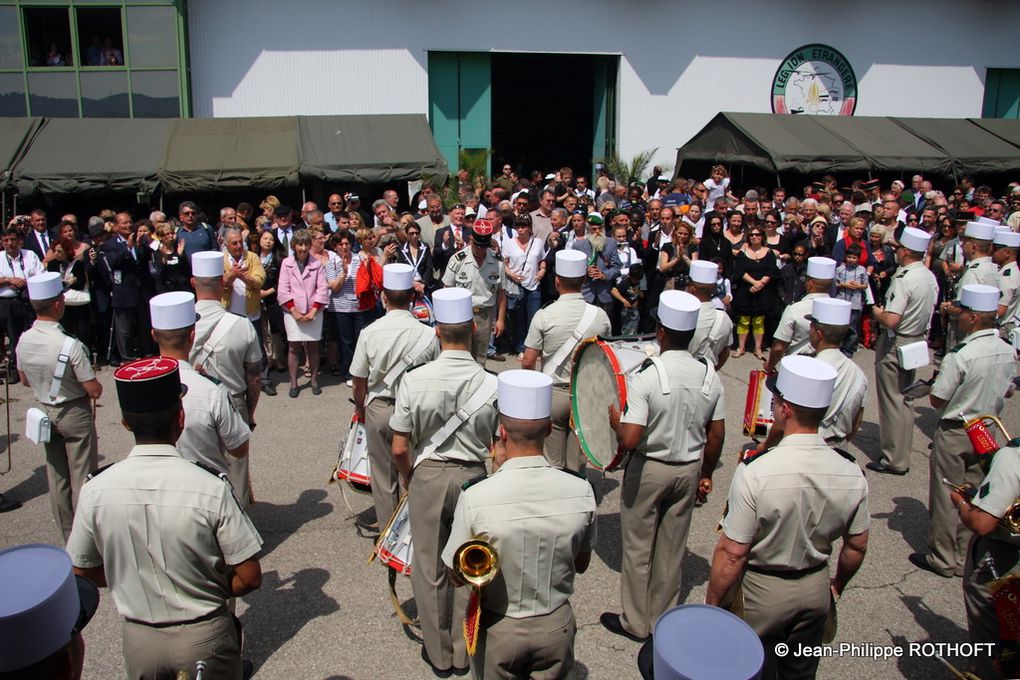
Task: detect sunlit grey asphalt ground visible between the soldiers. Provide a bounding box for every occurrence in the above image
[0,350,1020,680]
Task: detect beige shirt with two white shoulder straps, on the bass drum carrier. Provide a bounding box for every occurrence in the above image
[620,350,726,463]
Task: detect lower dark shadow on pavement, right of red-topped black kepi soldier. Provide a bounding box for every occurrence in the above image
[241,568,340,670]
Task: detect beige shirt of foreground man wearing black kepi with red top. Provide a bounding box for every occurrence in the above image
[67,444,262,623]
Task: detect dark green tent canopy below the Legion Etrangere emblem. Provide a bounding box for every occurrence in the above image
[676,113,1020,175]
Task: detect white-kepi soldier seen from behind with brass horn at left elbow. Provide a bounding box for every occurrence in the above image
[443,370,596,680]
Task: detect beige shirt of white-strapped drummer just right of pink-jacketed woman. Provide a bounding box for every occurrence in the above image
[351,309,440,399]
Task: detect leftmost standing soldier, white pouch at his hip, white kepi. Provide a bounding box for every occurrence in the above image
[17,272,103,540]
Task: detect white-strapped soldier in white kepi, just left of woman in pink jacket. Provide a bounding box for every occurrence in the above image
[189,251,262,510]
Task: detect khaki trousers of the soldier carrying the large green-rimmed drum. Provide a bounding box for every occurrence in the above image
[620,455,701,637]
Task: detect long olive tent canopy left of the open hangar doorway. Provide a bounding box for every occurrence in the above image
[0,114,448,196]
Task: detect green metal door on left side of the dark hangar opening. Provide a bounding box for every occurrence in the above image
[428,52,493,173]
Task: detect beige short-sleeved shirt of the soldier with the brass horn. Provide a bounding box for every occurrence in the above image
[443,456,596,619]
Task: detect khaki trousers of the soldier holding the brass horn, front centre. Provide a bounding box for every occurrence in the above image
[471,603,577,680]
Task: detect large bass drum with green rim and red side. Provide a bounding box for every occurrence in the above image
[570,337,659,470]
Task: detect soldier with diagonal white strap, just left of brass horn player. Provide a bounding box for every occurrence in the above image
[390,289,498,673]
